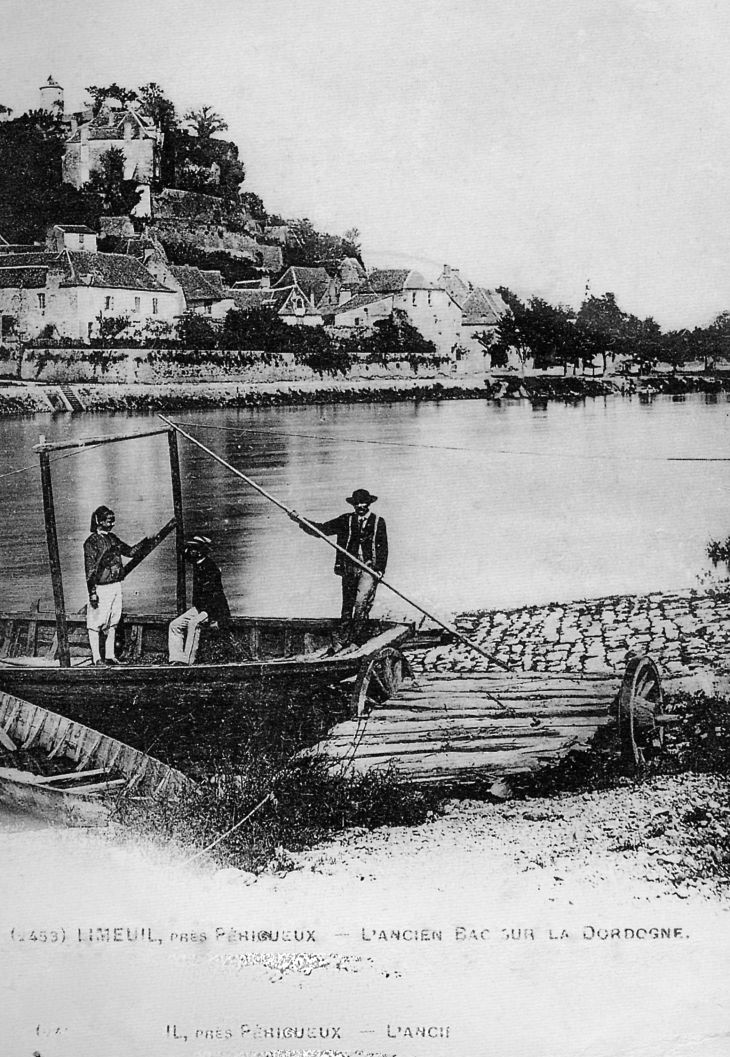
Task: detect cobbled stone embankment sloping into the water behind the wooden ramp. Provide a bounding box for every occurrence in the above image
[423,590,730,676]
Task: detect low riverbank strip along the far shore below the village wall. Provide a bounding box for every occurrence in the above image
[0,374,730,415]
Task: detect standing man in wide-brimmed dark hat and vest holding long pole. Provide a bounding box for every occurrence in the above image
[291,488,388,620]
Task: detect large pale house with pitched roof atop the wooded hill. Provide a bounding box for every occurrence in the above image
[63,99,163,187]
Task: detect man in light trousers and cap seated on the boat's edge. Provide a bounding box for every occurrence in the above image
[167,536,230,664]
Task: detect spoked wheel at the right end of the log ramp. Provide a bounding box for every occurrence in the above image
[618,654,665,774]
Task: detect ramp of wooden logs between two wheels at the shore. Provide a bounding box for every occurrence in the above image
[310,672,621,783]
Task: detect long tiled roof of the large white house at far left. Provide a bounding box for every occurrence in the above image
[2,249,172,294]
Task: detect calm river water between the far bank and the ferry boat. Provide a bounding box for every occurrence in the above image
[0,396,730,616]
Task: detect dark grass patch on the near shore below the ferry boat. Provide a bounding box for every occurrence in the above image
[117,755,442,873]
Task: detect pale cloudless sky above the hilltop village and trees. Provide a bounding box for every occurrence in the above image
[0,0,730,328]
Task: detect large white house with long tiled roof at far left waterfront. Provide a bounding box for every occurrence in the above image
[0,249,180,341]
